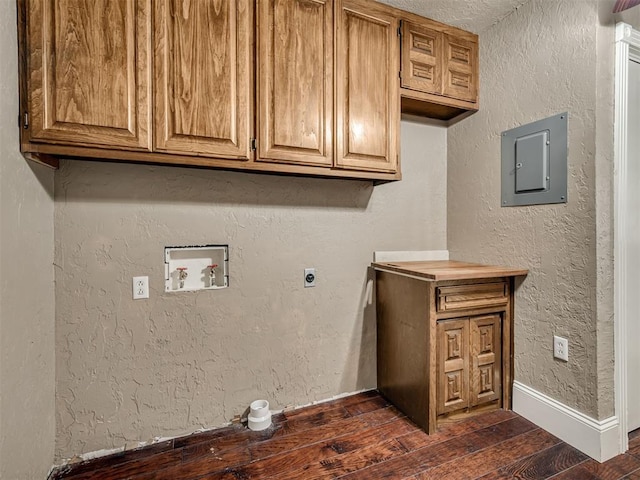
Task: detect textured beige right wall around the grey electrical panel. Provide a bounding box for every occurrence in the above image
[447,0,613,418]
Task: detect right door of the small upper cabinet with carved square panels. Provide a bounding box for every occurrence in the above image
[443,34,478,102]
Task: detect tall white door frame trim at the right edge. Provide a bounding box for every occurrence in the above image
[614,23,640,453]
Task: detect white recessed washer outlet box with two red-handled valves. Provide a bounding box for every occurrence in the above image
[164,245,229,292]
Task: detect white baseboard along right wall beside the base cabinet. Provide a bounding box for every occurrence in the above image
[513,382,622,462]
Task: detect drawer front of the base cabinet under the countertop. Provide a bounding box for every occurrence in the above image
[438,282,509,312]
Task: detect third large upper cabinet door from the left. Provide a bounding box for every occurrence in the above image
[257,0,333,166]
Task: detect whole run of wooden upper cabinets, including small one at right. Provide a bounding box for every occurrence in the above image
[16,0,478,178]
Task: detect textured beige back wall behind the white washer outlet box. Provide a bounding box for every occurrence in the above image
[55,120,447,458]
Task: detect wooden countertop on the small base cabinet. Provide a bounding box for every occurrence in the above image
[372,260,529,282]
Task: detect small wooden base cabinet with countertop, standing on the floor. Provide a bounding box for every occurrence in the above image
[373,261,527,433]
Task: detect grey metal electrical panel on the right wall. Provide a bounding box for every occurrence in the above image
[501,112,568,207]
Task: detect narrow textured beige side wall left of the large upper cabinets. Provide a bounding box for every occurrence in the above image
[0,1,55,480]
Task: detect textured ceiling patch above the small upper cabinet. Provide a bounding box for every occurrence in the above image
[379,0,528,33]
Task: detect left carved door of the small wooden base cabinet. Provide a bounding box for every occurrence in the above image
[437,318,469,415]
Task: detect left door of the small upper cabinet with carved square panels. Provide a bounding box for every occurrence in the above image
[401,20,443,94]
